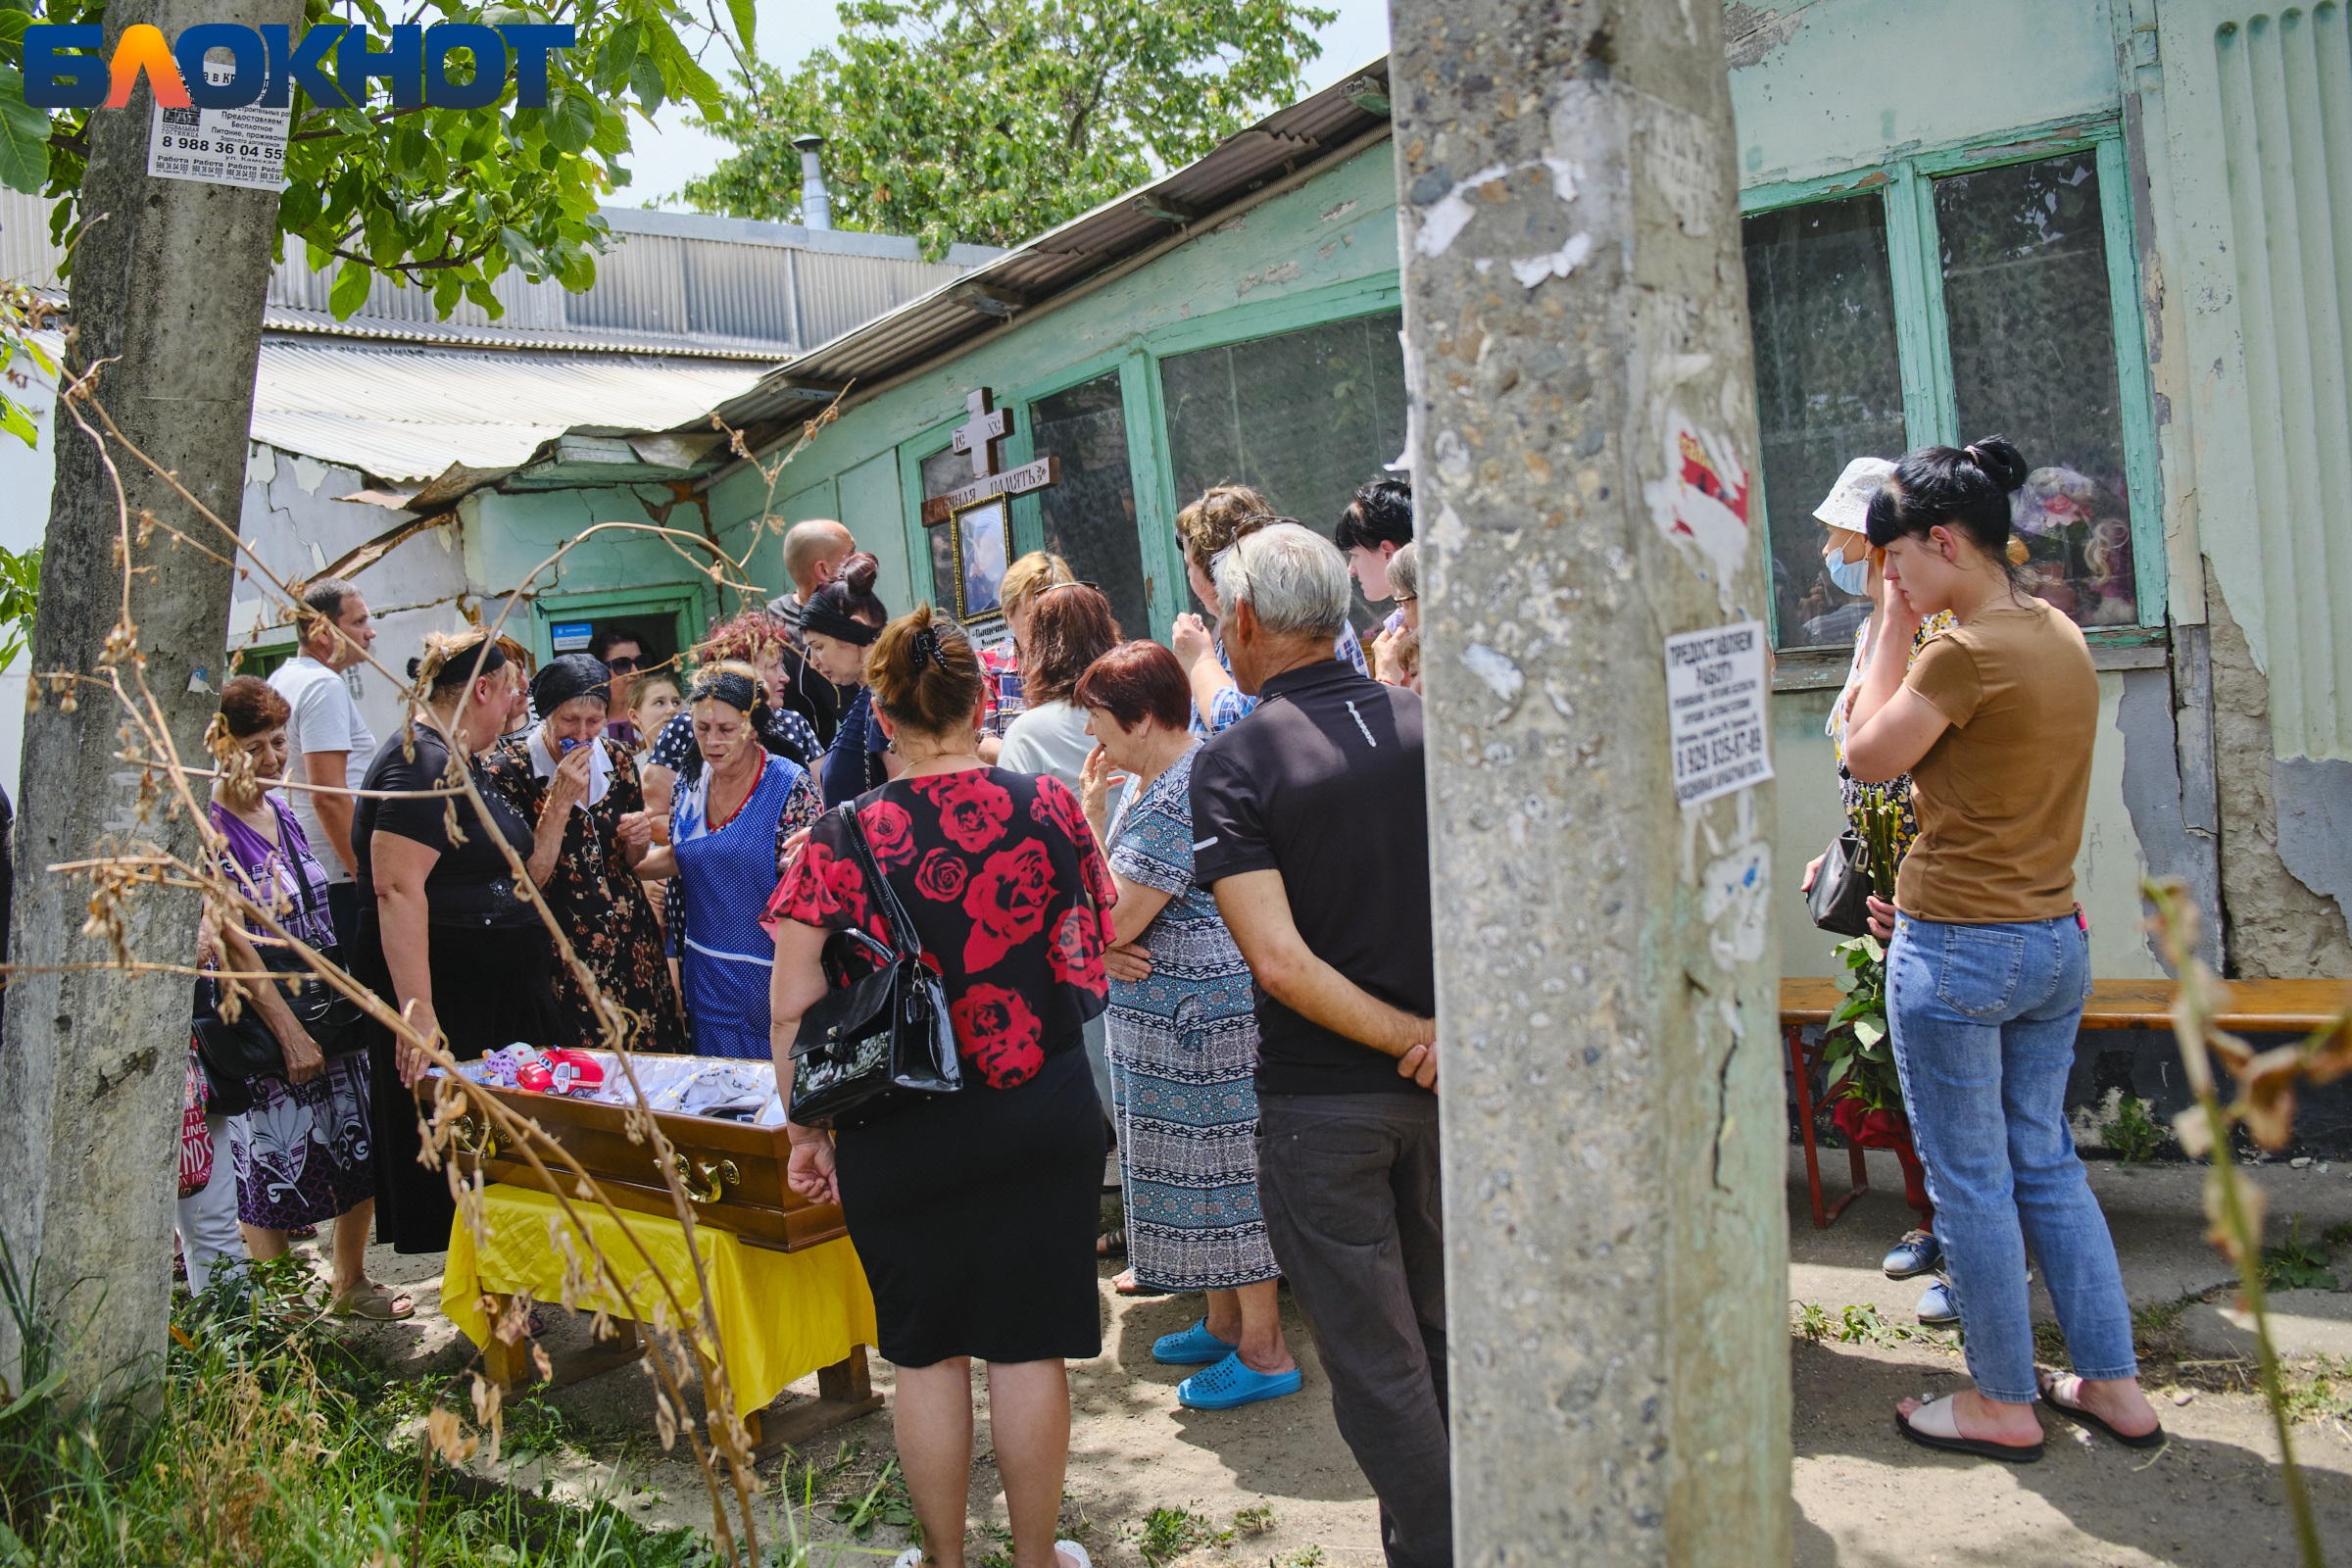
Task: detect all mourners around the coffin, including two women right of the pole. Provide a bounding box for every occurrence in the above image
[181,440,2162,1568]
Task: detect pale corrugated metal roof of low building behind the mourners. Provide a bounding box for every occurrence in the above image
[252,341,758,482]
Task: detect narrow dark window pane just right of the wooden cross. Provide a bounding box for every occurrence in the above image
[1030,371,1152,637]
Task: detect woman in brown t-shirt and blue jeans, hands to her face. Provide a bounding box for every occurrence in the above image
[1846,437,2164,1462]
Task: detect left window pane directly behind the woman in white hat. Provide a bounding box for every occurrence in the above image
[1742,195,1903,649]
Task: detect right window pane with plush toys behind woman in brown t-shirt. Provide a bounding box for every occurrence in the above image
[1936,153,2138,625]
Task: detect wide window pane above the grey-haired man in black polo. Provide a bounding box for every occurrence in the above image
[1159,311,1404,625]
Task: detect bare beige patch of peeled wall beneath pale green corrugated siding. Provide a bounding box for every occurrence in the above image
[2206,573,2352,980]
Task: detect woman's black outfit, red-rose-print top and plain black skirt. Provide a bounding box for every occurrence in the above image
[769,768,1117,1366]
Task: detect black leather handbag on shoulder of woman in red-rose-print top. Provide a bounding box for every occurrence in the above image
[790,804,964,1126]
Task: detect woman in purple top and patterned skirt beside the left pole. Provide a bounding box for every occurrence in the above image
[207,674,414,1319]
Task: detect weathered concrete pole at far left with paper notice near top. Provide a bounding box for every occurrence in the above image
[0,0,301,1392]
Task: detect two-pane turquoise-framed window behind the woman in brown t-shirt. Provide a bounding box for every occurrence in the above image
[1745,148,2152,649]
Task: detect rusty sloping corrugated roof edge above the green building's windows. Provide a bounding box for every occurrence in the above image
[719,57,1388,430]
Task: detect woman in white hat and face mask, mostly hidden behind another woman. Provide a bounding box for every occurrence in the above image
[1804,459,1959,1326]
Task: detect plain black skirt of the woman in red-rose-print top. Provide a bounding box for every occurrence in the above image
[835,1039,1103,1366]
